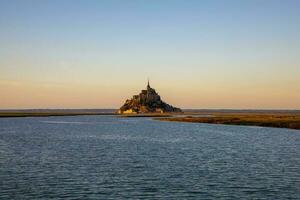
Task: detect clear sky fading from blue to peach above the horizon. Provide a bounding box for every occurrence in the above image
[0,0,300,109]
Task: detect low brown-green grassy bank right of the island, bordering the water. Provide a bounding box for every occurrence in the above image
[156,113,300,129]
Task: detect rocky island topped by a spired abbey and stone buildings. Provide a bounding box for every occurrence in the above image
[118,80,182,114]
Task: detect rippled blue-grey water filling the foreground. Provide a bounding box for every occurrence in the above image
[0,116,300,199]
